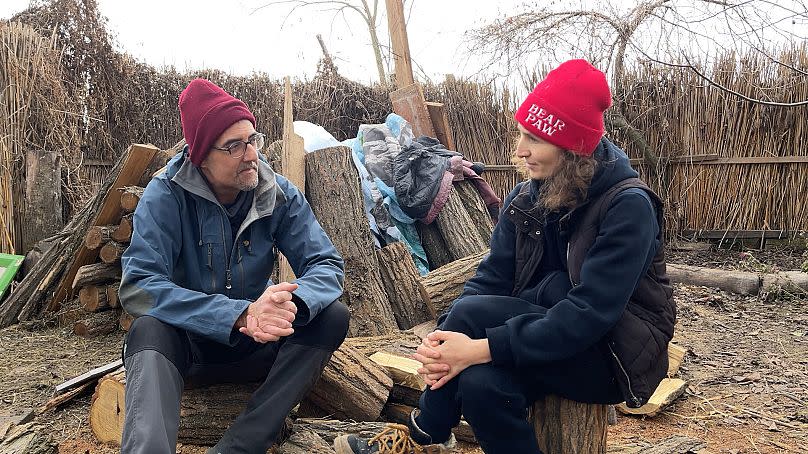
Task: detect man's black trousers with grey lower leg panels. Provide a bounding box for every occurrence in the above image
[121,302,350,454]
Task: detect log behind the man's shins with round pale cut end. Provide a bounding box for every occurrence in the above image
[89,371,259,445]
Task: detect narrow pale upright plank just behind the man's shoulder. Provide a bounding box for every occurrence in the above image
[278,77,306,282]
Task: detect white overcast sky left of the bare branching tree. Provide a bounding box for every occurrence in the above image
[0,0,536,82]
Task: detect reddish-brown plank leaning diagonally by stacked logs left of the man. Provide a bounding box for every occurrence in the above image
[47,144,158,311]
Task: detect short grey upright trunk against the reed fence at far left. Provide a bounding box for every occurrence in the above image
[19,150,64,254]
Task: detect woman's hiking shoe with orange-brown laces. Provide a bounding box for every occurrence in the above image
[334,424,456,454]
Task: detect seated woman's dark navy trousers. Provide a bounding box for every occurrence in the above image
[416,295,623,454]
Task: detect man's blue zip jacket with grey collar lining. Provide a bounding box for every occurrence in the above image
[119,147,344,345]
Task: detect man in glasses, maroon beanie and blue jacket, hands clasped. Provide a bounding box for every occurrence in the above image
[120,79,349,454]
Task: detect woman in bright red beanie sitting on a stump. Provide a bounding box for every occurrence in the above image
[335,60,676,453]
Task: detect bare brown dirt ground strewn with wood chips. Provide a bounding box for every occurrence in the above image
[0,245,808,454]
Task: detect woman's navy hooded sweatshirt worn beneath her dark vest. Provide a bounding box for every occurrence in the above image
[446,139,660,367]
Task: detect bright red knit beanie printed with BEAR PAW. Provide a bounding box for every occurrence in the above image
[514,60,612,156]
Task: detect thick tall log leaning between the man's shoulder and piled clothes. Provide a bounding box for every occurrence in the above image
[306,147,398,336]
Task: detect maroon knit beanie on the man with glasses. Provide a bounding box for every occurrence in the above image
[180,79,255,167]
